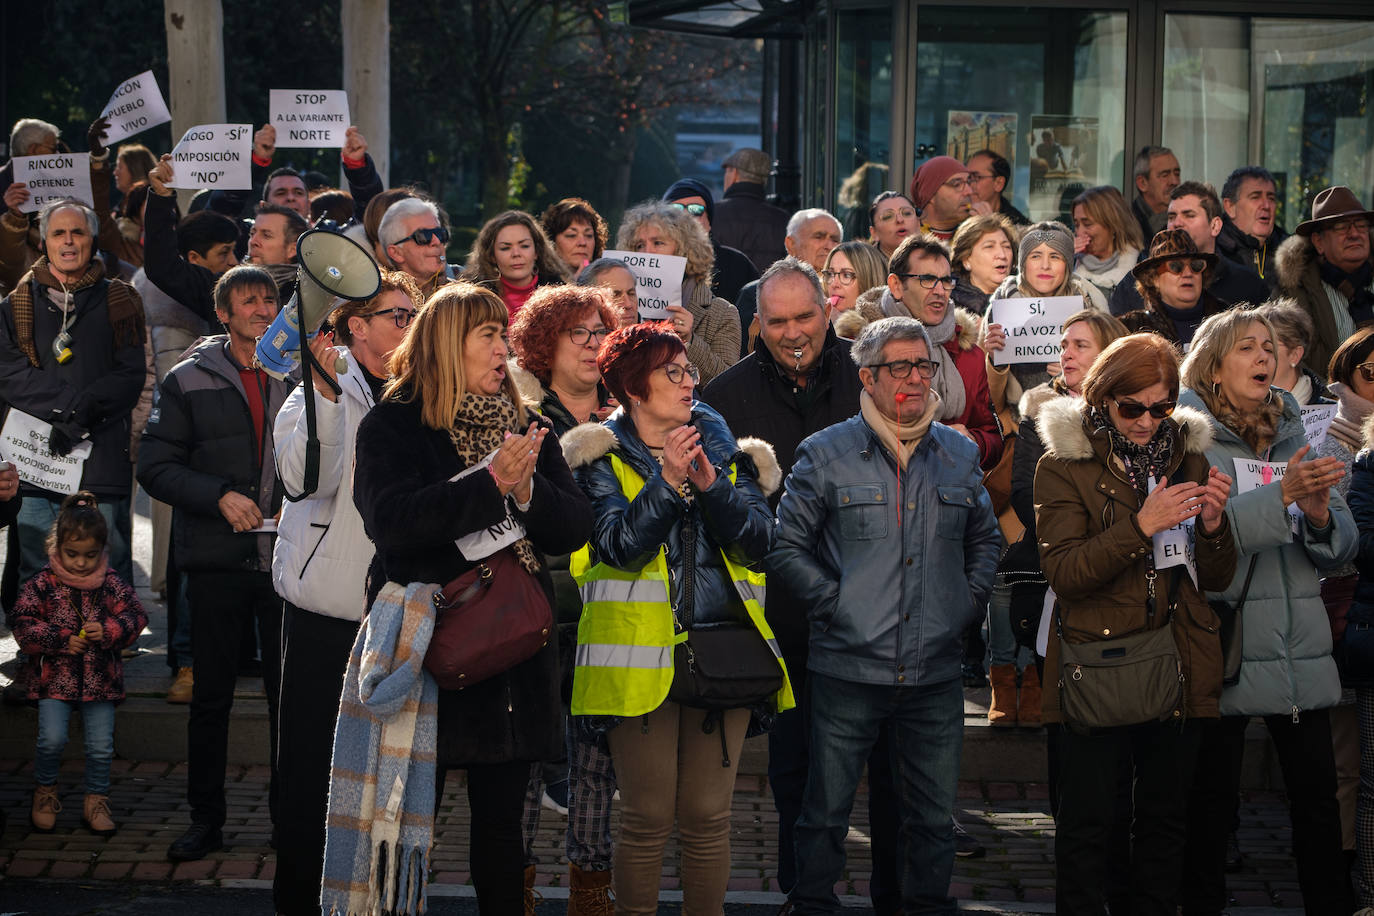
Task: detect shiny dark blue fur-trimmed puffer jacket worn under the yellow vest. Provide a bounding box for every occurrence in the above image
[562,401,779,626]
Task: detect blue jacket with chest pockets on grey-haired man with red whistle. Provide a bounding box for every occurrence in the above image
[767,415,1002,687]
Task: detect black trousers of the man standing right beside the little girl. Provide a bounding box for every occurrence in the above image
[185,570,282,827]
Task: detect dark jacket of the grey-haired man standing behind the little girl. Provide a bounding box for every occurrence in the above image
[139,335,291,573]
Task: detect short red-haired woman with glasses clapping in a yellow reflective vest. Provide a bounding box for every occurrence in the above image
[562,324,793,913]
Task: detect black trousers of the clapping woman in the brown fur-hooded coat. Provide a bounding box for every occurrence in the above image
[1054,722,1203,916]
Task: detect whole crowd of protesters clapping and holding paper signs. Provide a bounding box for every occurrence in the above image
[0,76,1374,916]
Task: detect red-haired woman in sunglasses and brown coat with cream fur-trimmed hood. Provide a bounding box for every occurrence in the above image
[1035,334,1235,915]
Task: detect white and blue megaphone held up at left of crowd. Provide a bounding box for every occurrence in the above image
[257,229,382,379]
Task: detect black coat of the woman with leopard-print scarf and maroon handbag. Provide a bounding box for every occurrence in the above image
[353,401,592,766]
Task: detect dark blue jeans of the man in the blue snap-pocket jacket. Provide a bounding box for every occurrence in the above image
[790,672,963,913]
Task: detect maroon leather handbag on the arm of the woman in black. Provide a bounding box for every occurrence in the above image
[425,548,554,691]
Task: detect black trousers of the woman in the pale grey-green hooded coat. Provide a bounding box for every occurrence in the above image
[1180,709,1356,916]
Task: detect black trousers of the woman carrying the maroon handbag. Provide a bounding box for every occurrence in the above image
[434,761,530,916]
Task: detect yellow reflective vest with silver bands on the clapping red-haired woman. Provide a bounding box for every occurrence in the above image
[570,453,797,715]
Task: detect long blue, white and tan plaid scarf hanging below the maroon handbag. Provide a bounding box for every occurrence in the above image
[320,582,438,916]
